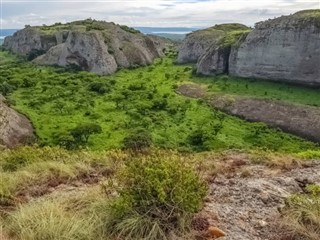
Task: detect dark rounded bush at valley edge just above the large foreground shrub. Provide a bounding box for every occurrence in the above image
[123,129,152,151]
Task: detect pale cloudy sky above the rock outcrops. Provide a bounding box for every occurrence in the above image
[0,0,320,29]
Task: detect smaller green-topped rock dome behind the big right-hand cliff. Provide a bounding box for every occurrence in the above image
[177,23,249,63]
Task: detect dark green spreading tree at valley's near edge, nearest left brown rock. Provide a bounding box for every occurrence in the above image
[70,123,102,144]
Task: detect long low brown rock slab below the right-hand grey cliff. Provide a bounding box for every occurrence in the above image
[177,84,320,142]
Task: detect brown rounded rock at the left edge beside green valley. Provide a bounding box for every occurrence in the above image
[0,95,35,148]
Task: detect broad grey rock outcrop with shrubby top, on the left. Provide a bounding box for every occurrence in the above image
[4,19,168,74]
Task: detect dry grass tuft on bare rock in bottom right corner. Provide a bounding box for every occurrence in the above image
[282,185,320,240]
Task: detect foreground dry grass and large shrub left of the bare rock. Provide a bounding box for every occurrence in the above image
[0,147,207,240]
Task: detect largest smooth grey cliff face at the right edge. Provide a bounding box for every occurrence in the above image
[229,10,320,85]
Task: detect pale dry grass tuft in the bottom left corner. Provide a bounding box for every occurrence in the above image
[6,201,95,240]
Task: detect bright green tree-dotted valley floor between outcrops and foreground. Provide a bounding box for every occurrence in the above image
[1,52,314,151]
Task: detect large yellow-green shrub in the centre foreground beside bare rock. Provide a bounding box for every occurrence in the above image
[106,156,207,240]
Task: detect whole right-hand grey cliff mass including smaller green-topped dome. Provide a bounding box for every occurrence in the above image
[177,10,320,85]
